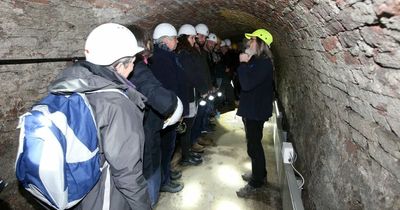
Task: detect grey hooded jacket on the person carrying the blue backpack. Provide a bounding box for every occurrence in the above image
[49,62,150,210]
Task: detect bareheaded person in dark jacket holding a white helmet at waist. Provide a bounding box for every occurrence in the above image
[128,26,183,208]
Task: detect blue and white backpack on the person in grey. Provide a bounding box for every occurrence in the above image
[16,93,102,209]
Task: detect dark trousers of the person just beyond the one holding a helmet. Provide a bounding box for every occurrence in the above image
[161,124,177,186]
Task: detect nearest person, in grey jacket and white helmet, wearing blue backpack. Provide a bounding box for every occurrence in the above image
[49,23,150,210]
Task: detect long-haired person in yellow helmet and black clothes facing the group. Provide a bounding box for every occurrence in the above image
[236,29,273,197]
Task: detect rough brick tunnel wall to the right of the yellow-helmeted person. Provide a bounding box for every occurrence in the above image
[275,1,400,209]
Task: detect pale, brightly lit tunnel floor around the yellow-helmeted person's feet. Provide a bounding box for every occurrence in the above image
[155,110,282,210]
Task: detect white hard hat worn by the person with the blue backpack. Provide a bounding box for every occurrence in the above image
[85,23,143,65]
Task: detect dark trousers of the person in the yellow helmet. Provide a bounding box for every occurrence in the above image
[243,118,267,187]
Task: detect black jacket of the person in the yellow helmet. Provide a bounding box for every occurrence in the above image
[237,56,273,121]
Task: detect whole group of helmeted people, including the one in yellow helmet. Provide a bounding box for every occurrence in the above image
[50,20,273,209]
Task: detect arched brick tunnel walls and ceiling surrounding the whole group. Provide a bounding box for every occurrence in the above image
[0,0,400,209]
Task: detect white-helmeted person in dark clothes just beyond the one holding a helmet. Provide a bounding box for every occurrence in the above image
[150,23,189,193]
